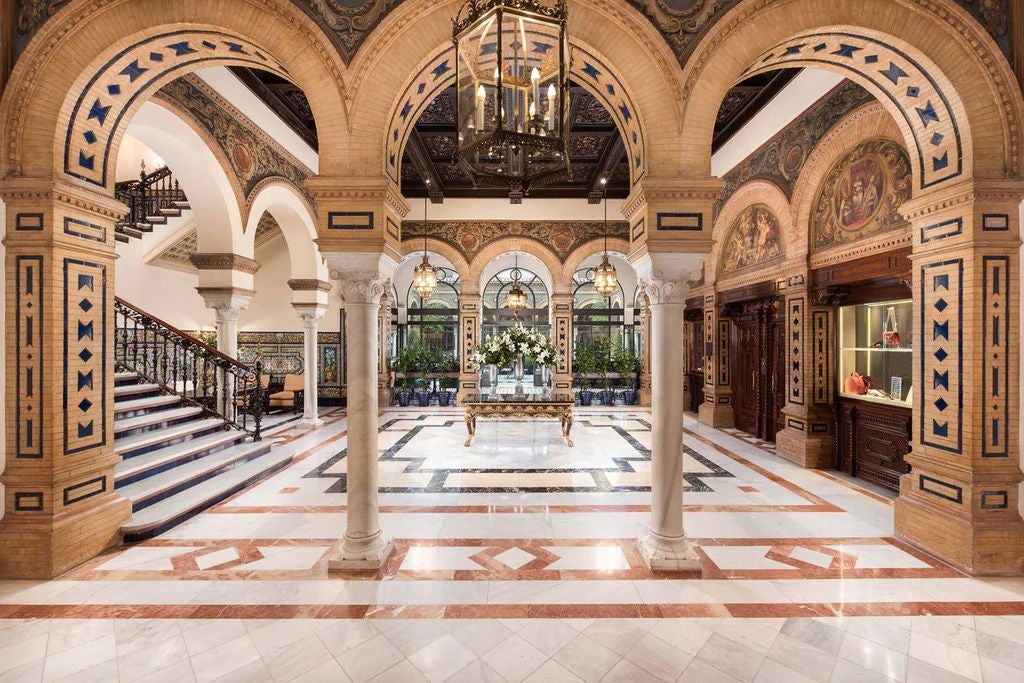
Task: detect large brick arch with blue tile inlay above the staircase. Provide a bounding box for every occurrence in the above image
[0,0,347,188]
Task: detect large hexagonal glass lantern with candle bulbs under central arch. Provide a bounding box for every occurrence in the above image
[452,0,570,204]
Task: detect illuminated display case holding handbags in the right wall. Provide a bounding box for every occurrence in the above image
[838,299,913,405]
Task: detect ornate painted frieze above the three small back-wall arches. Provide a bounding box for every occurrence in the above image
[401,220,630,262]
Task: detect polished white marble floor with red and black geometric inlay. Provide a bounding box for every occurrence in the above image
[0,408,1024,683]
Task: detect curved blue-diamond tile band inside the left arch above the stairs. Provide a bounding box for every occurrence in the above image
[63,30,287,187]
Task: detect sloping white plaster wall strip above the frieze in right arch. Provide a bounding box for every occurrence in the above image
[711,69,843,177]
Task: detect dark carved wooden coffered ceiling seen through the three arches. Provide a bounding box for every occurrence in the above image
[231,67,799,202]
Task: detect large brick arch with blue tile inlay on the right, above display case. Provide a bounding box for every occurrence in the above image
[682,0,1024,187]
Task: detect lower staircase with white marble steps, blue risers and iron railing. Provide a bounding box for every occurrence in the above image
[114,298,292,542]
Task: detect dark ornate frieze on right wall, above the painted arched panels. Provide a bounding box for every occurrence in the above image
[715,81,874,216]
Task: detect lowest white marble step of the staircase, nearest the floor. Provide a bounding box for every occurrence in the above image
[120,441,292,543]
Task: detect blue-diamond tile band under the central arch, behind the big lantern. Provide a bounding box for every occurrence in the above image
[384,44,646,189]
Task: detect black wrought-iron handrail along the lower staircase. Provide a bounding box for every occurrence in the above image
[114,297,266,441]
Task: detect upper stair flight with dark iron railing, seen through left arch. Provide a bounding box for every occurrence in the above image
[114,163,190,243]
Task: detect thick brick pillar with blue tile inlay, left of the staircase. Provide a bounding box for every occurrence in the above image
[0,178,131,579]
